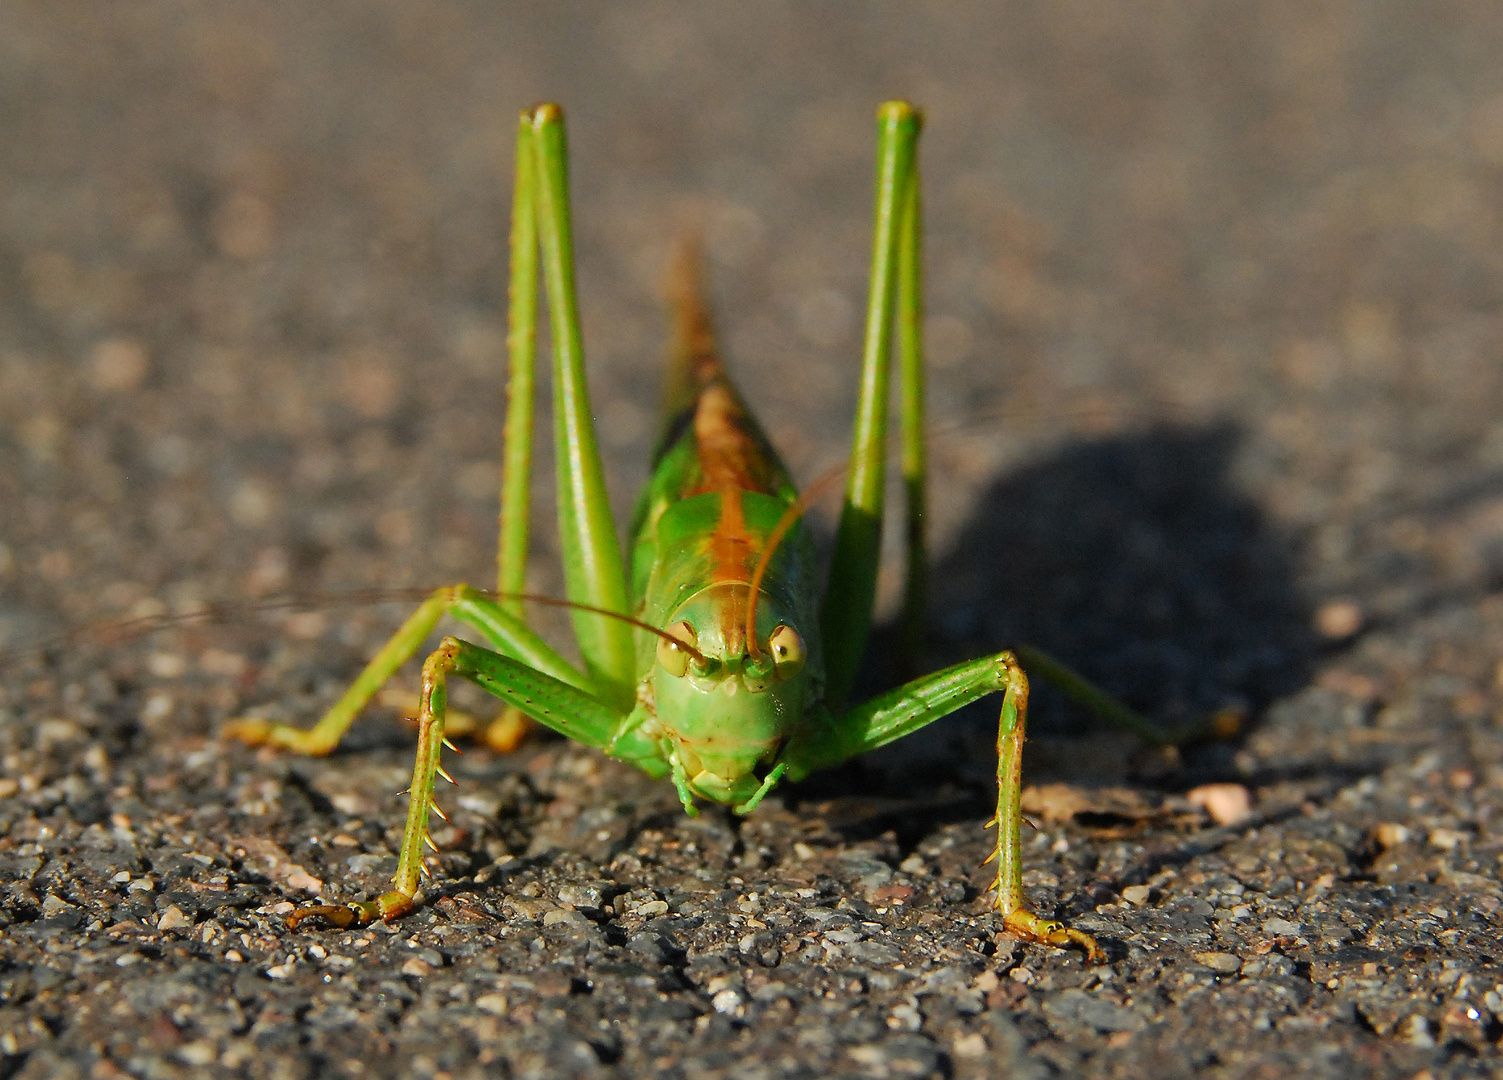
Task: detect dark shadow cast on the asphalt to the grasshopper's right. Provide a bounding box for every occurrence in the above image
[798,422,1318,817]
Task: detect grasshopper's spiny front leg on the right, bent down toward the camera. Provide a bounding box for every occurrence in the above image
[783,652,1106,963]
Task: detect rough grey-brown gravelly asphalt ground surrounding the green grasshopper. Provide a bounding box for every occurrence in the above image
[0,0,1503,1080]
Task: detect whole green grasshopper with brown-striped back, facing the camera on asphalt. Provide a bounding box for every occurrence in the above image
[230,102,1141,960]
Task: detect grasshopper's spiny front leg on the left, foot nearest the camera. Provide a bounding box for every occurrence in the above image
[287,637,625,927]
